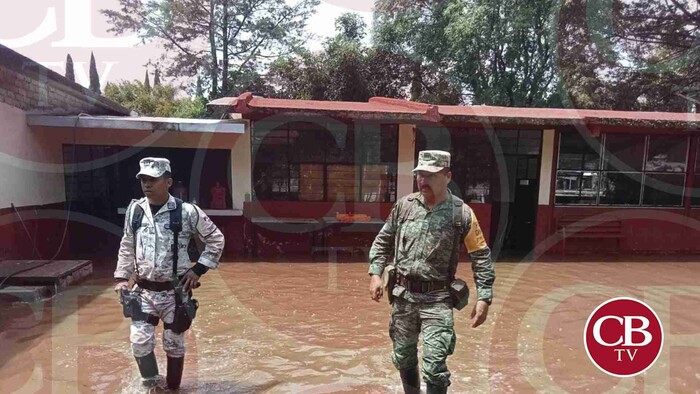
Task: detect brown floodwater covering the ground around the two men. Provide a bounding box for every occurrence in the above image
[0,257,700,393]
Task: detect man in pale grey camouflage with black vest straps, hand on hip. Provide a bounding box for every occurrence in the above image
[114,157,224,389]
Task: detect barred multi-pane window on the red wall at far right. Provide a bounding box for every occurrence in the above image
[555,132,689,207]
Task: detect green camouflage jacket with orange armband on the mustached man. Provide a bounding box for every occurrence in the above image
[369,193,496,302]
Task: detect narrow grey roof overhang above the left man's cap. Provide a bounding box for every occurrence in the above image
[27,115,248,134]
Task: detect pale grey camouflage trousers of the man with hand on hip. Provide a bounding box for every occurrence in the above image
[129,289,185,357]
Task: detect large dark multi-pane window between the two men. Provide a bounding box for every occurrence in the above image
[253,122,398,202]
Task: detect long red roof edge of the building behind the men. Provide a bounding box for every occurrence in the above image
[208,92,700,132]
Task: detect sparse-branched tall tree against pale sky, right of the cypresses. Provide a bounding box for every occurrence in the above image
[102,0,319,98]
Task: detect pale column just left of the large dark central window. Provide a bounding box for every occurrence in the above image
[231,122,253,209]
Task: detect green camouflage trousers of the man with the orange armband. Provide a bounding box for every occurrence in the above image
[389,297,457,387]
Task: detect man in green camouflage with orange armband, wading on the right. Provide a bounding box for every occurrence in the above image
[369,151,495,394]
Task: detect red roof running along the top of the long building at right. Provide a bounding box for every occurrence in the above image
[209,92,700,128]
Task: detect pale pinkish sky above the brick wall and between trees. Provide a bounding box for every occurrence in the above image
[0,0,374,87]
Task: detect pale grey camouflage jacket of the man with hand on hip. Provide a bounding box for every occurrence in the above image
[114,196,224,282]
